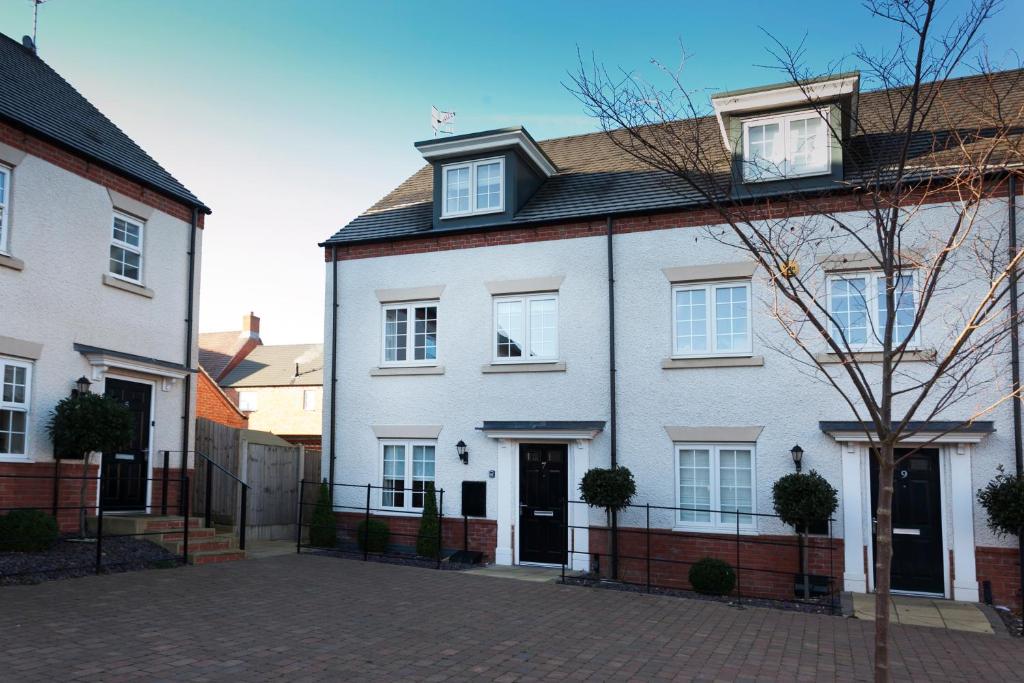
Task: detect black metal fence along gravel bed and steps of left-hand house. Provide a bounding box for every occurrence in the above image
[0,473,190,584]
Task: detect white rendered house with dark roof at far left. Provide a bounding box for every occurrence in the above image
[0,35,210,528]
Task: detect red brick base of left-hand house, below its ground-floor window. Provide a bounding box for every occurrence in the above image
[0,461,99,532]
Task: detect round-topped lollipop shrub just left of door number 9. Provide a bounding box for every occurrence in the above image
[771,470,839,598]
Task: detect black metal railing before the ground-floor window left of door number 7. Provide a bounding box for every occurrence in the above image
[295,480,444,568]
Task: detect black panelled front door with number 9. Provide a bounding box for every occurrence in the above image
[871,449,945,594]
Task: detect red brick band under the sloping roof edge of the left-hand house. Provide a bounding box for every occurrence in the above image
[0,117,204,227]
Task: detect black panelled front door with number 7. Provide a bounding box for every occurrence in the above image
[519,443,568,564]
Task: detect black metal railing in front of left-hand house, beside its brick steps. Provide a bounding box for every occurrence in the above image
[0,469,190,583]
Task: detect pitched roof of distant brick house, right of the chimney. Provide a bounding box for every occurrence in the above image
[220,344,324,388]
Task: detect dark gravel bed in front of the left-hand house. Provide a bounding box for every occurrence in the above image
[0,537,181,586]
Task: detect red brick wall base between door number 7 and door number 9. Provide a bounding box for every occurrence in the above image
[590,526,843,600]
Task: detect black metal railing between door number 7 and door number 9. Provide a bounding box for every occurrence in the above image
[555,501,839,613]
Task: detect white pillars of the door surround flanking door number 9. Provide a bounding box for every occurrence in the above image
[829,431,986,602]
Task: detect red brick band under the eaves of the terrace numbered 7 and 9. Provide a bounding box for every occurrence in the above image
[324,187,1006,261]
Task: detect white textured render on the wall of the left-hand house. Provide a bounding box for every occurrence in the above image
[0,149,203,467]
